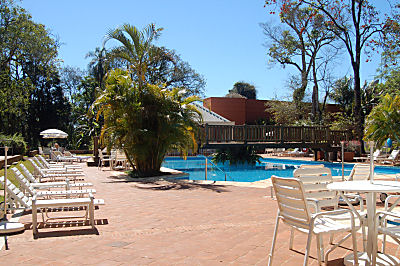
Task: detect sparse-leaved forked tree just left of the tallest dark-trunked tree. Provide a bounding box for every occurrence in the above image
[261,0,334,120]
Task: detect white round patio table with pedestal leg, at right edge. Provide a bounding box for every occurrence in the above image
[327,180,400,265]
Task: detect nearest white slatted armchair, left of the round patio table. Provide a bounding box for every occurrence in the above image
[268,176,359,265]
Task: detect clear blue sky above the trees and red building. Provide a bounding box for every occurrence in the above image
[20,0,377,99]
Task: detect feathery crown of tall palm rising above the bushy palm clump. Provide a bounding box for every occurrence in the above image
[104,24,165,88]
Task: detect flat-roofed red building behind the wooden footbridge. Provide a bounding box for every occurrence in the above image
[203,97,340,125]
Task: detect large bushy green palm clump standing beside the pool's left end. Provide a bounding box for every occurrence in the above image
[94,69,199,176]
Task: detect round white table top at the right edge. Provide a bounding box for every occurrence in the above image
[327,180,400,192]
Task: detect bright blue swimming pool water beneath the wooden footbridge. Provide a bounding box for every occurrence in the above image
[163,157,400,182]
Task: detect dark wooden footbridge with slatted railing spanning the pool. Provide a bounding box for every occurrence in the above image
[203,124,352,150]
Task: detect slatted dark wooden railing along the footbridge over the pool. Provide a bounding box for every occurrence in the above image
[204,124,351,148]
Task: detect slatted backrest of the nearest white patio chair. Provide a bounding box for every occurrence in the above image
[271,176,311,228]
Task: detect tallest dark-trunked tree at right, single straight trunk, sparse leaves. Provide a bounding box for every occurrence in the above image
[298,0,399,143]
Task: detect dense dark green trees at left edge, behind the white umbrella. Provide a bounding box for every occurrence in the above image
[0,0,70,146]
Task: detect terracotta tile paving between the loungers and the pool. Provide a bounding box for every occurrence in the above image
[0,163,400,265]
